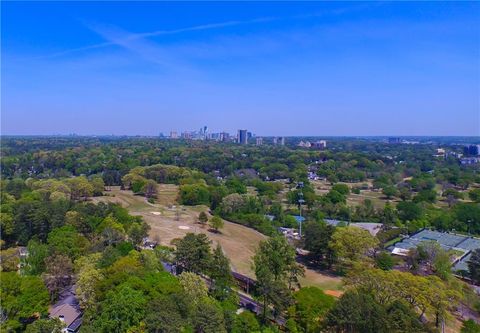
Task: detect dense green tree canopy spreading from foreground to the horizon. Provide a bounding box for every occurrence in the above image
[0,137,480,333]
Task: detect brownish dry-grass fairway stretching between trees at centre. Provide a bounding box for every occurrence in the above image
[92,184,341,290]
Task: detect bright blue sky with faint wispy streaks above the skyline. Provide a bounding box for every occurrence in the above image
[1,1,480,136]
